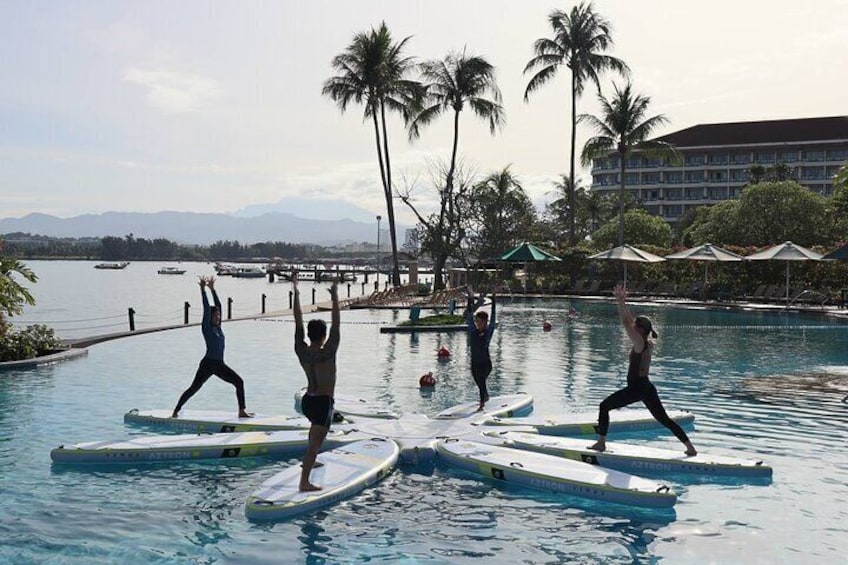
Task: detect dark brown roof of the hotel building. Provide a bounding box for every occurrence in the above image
[657,116,848,147]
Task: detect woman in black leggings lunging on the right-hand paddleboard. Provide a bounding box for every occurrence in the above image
[589,285,698,457]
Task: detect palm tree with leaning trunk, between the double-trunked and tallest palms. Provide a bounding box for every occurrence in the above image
[409,49,504,284]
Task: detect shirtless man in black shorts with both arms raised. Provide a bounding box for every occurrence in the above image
[292,274,340,491]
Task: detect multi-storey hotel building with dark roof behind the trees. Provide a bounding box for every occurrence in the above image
[592,116,848,227]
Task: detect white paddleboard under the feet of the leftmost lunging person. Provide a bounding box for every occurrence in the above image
[124,408,322,433]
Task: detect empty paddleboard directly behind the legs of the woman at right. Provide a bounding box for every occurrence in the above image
[479,408,695,436]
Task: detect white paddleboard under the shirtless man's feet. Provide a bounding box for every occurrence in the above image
[245,438,399,520]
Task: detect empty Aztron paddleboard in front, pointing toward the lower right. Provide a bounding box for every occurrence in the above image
[436,439,677,508]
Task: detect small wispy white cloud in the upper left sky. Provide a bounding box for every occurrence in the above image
[123,68,225,114]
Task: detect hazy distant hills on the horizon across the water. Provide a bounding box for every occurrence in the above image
[0,206,400,246]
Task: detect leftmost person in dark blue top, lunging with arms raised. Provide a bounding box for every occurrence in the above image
[171,277,252,418]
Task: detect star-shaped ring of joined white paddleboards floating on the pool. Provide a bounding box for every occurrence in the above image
[51,392,772,520]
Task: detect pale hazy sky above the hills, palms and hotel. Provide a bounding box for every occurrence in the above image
[0,0,848,224]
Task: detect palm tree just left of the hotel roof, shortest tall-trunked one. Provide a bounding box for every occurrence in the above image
[578,82,680,245]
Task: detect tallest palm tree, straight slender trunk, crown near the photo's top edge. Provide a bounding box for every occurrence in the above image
[524,2,630,245]
